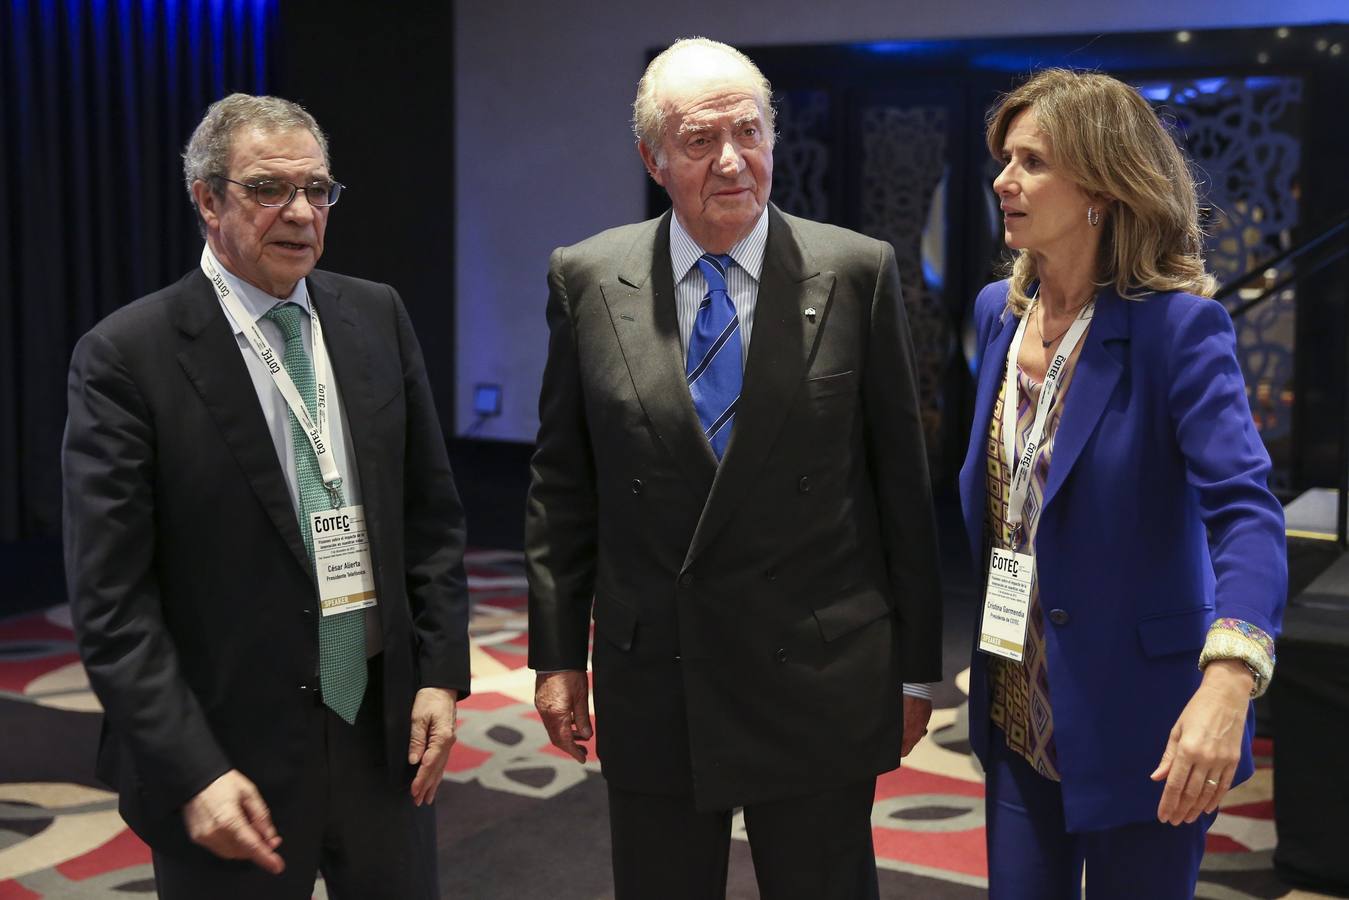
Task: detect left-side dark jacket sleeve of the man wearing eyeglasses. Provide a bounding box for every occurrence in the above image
[61,331,232,814]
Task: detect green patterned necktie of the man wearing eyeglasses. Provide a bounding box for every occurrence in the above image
[264,302,368,723]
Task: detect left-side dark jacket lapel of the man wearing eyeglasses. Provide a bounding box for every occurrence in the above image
[173,271,314,579]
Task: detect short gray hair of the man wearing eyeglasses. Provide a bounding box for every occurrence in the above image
[182,93,331,236]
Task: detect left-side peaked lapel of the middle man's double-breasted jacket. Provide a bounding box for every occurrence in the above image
[600,212,716,498]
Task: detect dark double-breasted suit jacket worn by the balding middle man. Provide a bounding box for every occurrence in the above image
[525,208,942,808]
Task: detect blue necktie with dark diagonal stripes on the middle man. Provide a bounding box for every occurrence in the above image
[684,254,745,459]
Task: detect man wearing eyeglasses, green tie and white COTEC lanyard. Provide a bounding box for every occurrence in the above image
[63,94,468,900]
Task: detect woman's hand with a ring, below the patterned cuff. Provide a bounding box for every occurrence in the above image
[1151,660,1255,824]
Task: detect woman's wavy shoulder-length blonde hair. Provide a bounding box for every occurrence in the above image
[985,69,1215,316]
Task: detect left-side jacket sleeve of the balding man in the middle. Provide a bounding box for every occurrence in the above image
[525,242,599,671]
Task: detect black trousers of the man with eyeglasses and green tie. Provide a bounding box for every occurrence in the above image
[154,661,440,900]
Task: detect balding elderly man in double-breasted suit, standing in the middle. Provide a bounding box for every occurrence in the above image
[526,39,940,900]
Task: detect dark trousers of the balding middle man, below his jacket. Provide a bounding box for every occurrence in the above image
[608,779,880,900]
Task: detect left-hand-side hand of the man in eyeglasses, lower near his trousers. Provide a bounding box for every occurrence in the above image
[182,769,286,874]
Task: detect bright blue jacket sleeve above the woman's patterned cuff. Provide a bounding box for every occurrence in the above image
[1167,300,1288,637]
